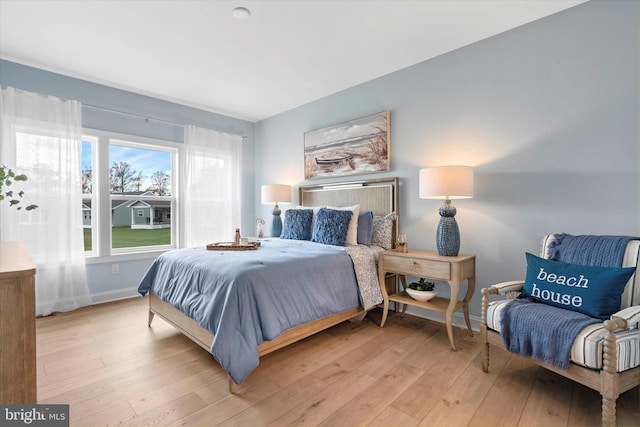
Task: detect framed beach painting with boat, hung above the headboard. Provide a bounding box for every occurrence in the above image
[304,110,391,179]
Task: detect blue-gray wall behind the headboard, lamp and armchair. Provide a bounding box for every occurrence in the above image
[255,1,640,328]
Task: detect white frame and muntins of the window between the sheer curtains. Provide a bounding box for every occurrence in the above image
[80,128,181,264]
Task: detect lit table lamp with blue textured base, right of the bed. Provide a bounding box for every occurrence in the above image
[420,166,473,256]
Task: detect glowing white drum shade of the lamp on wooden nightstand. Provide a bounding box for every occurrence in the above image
[420,166,473,199]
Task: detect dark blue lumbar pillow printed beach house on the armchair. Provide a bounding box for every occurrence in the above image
[522,253,635,320]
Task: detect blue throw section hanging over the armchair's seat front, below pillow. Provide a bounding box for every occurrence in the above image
[500,298,600,369]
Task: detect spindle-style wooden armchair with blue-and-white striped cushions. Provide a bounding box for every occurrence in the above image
[480,235,640,426]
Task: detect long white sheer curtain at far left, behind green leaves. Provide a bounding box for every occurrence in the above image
[0,87,91,315]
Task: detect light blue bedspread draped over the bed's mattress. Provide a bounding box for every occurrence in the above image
[138,239,360,384]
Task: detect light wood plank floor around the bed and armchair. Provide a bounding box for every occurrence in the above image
[37,299,640,427]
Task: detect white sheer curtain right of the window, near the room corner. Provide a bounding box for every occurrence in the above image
[180,125,242,247]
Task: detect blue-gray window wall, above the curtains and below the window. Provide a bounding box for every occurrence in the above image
[0,60,255,302]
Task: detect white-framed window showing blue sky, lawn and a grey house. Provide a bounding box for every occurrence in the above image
[82,131,177,256]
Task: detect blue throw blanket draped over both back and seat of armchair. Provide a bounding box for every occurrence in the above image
[500,234,638,369]
